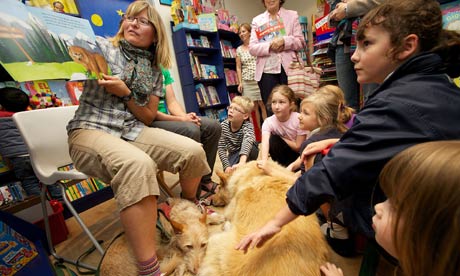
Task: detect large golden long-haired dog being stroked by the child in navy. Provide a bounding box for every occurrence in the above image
[199,161,328,276]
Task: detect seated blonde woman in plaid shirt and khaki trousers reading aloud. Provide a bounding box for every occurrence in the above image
[67,0,210,275]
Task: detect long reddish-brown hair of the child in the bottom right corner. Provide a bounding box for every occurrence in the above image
[380,141,460,276]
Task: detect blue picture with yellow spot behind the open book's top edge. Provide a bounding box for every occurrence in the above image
[77,0,133,37]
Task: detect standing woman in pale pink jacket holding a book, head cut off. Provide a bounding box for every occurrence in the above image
[249,0,303,115]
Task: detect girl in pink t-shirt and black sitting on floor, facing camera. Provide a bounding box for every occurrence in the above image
[260,85,308,167]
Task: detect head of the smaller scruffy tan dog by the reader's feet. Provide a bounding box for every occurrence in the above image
[170,200,209,274]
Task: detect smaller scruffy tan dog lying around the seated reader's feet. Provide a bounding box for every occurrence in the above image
[101,198,223,276]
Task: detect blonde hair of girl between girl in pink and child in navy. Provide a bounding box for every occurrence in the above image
[300,85,353,132]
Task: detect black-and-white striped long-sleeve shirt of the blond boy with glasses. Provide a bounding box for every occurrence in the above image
[217,120,256,171]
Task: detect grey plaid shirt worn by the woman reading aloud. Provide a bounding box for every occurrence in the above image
[67,37,162,141]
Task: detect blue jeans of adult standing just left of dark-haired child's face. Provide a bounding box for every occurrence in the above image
[335,45,359,110]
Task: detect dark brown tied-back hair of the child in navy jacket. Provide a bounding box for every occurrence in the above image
[356,0,460,77]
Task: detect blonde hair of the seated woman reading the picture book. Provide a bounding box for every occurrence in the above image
[111,0,171,68]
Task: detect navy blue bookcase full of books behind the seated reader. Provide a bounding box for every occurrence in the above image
[171,25,239,120]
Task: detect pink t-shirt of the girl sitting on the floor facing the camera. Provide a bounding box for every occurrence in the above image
[262,112,308,141]
